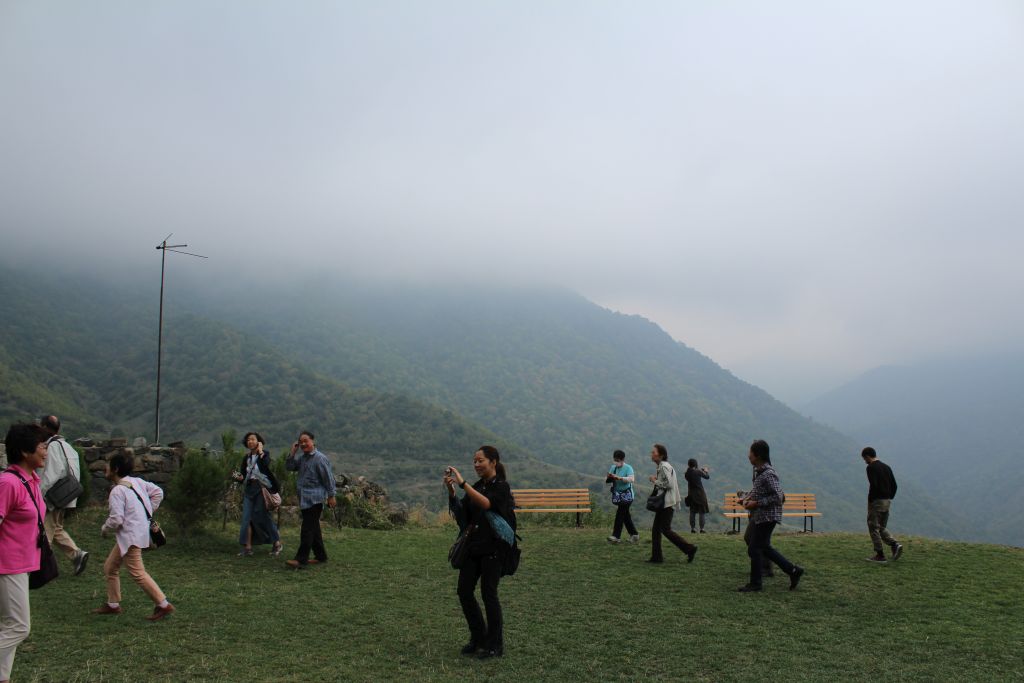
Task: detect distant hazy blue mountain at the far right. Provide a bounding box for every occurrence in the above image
[804,353,1024,546]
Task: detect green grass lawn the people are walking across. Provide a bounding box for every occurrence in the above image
[12,511,1024,683]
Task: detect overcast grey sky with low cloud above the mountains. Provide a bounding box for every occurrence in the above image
[0,0,1024,404]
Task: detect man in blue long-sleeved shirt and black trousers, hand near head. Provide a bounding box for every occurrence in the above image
[285,431,338,569]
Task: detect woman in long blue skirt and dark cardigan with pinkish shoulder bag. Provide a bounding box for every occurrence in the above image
[231,432,283,557]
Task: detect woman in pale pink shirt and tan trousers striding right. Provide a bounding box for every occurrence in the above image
[92,453,174,622]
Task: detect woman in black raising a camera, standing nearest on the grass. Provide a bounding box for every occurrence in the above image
[444,445,516,658]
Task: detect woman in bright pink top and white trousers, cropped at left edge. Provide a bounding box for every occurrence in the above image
[0,424,50,683]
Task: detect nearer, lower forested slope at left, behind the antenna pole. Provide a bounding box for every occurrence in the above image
[0,270,597,506]
